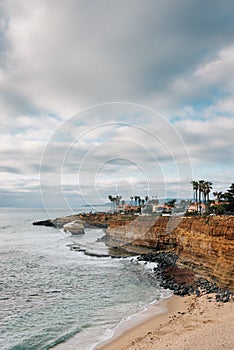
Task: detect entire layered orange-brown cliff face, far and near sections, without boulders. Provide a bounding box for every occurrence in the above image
[107,216,234,291]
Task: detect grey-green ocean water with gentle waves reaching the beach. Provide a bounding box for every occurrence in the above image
[0,208,170,350]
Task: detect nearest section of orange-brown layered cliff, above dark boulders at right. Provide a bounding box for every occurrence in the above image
[174,216,234,290]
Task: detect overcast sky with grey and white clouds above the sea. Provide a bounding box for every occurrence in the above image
[0,0,234,207]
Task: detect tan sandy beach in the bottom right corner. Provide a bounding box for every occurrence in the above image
[99,295,234,350]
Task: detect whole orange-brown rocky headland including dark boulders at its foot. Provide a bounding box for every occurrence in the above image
[35,213,234,299]
